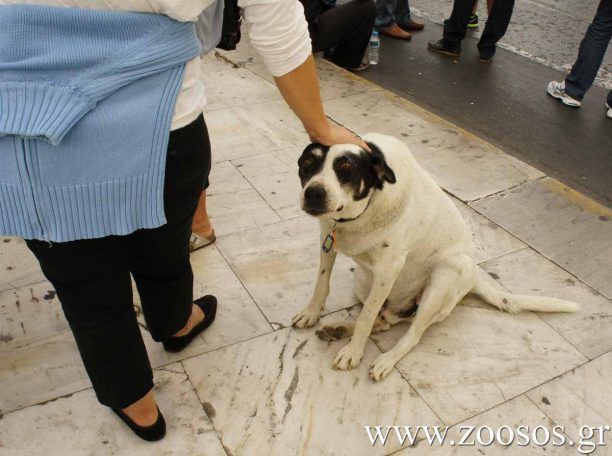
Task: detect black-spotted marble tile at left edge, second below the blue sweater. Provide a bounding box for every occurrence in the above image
[0,281,68,352]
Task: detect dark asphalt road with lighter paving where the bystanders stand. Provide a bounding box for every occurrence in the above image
[361,0,612,207]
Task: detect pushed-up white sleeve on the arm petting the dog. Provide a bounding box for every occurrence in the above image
[238,0,312,77]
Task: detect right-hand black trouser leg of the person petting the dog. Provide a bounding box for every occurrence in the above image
[122,116,210,342]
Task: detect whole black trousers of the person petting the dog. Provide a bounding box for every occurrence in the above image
[27,116,210,408]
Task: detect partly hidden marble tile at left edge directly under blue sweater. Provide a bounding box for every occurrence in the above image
[0,236,45,291]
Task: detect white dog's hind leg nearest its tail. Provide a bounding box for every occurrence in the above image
[370,255,475,381]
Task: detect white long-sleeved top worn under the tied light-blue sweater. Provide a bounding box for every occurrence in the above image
[0,0,312,130]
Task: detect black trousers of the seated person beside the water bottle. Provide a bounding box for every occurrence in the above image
[309,0,376,68]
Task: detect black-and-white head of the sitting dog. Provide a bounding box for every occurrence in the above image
[298,143,395,220]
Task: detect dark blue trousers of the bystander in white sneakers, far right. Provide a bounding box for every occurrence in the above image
[565,0,612,106]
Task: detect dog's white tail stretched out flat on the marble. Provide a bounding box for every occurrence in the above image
[472,270,580,314]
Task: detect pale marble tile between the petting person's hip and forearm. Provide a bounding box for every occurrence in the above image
[204,109,279,163]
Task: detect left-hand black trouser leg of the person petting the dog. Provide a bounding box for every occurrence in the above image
[26,237,153,409]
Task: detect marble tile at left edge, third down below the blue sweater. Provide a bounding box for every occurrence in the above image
[0,330,91,416]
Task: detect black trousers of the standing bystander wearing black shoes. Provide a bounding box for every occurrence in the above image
[442,0,514,58]
